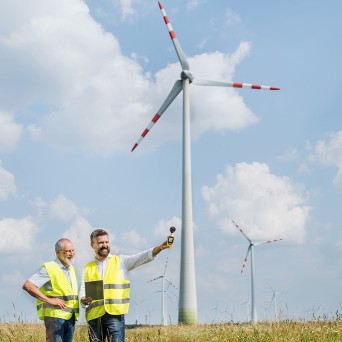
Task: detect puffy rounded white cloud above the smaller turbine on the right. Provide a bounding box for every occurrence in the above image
[202,162,310,243]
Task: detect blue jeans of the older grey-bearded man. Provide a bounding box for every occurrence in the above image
[44,315,75,342]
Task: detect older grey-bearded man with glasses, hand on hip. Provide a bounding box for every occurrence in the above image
[23,238,79,342]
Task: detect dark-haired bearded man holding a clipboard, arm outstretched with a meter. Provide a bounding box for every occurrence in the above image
[79,229,168,342]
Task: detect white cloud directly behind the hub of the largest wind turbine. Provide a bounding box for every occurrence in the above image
[146,42,258,144]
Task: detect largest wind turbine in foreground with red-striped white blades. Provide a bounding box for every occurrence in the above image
[132,1,279,323]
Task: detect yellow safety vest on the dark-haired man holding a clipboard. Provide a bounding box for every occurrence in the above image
[84,255,130,321]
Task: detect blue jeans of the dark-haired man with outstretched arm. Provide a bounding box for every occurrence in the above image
[88,312,125,342]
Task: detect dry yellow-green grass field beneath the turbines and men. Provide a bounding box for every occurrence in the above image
[0,321,342,342]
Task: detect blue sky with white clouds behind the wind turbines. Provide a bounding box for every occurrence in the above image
[0,0,342,324]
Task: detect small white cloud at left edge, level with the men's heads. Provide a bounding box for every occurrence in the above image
[0,216,38,254]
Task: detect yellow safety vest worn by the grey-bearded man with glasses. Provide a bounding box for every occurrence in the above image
[37,261,79,320]
